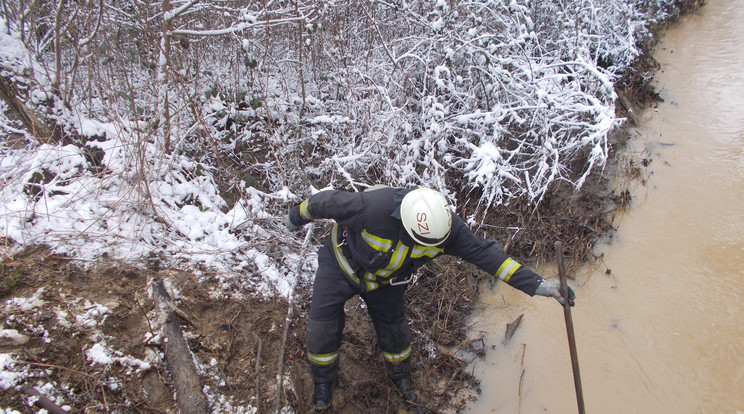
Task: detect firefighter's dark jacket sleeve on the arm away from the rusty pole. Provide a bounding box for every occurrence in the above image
[289,190,365,226]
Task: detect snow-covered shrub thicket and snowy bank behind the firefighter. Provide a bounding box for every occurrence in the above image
[0,0,678,277]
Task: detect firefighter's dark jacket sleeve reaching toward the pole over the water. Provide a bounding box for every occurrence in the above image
[445,215,543,296]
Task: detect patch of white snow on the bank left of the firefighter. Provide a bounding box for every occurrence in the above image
[0,123,296,279]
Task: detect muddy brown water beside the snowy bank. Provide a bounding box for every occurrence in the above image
[469,0,744,414]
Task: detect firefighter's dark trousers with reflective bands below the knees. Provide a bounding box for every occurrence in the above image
[305,241,411,382]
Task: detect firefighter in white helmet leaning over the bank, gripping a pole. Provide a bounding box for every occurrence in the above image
[285,186,573,411]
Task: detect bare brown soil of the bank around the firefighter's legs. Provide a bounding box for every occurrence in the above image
[0,246,477,413]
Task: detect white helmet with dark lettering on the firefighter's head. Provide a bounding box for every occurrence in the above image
[400,188,452,246]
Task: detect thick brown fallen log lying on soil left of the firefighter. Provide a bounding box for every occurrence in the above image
[152,279,209,414]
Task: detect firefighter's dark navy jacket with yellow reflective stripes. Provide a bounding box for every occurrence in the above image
[289,186,543,296]
